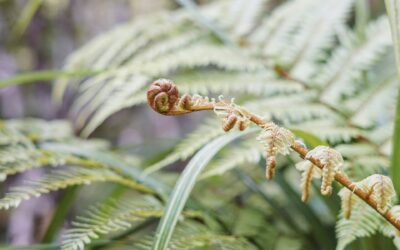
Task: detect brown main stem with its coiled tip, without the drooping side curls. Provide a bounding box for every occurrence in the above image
[147,79,400,230]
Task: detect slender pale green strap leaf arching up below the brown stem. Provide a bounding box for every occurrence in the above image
[152,129,253,250]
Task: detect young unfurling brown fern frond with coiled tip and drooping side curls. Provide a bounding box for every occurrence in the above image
[147,79,400,230]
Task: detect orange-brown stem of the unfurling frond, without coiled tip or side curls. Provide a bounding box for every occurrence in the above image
[149,82,400,230]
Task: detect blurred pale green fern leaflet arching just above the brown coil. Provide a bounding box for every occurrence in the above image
[66,39,263,133]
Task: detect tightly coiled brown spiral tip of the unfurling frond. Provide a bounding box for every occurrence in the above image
[147,79,179,113]
